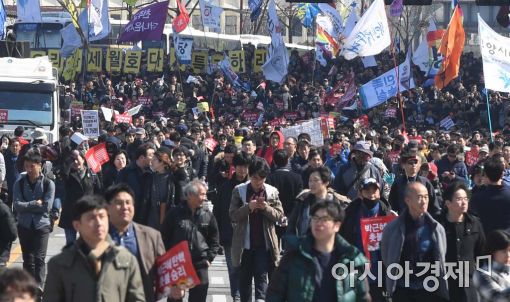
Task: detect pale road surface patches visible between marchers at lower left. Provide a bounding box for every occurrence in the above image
[8,227,232,302]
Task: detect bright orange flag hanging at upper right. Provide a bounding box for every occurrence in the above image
[435,5,466,89]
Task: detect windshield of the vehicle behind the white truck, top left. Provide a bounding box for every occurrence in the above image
[14,23,63,49]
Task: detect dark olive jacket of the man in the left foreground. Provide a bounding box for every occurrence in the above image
[43,239,145,302]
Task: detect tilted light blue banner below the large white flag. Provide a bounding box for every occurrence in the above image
[359,57,414,109]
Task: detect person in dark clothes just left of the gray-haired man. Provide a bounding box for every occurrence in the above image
[140,147,175,230]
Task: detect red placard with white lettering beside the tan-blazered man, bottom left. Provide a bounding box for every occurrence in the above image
[156,241,200,299]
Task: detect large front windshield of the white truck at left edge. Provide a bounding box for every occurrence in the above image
[0,91,54,126]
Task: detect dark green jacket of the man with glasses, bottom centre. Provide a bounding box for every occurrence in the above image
[266,234,370,302]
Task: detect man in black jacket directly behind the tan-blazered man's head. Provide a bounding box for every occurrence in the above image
[115,144,155,222]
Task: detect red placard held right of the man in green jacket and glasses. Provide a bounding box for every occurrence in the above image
[360,215,397,261]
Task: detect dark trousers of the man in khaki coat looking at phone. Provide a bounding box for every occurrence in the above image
[238,247,272,302]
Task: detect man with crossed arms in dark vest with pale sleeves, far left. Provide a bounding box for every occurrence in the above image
[13,149,55,287]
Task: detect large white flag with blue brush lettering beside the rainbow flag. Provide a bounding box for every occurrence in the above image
[341,0,391,60]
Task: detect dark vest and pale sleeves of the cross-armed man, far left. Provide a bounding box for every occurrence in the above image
[13,174,55,229]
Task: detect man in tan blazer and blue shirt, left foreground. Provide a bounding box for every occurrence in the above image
[104,184,165,301]
